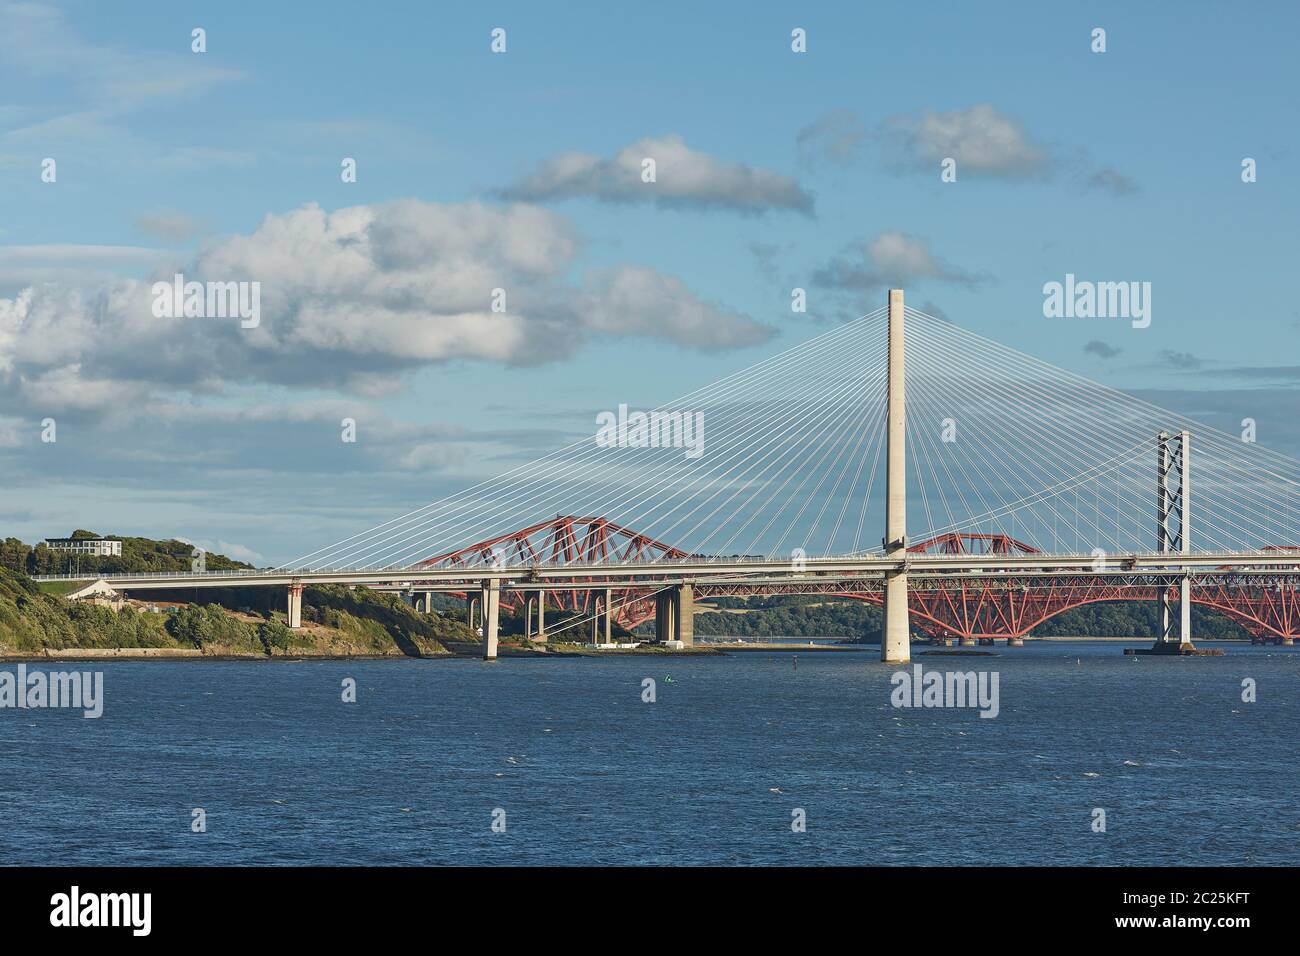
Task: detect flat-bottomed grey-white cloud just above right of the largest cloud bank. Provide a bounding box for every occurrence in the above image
[503,135,813,216]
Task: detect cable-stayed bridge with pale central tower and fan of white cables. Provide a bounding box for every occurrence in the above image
[40,290,1300,661]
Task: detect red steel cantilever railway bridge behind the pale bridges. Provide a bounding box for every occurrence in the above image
[413,516,1300,641]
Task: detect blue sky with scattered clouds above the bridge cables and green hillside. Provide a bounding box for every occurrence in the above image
[0,1,1300,562]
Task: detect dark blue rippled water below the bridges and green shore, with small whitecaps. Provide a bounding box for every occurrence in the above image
[0,644,1300,865]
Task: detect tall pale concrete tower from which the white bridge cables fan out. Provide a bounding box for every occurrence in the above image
[880,289,911,663]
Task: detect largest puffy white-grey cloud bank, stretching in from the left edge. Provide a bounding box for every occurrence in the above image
[0,200,774,411]
